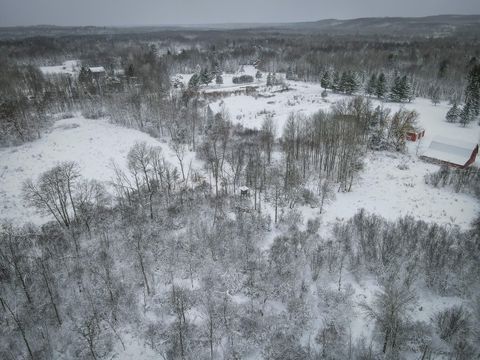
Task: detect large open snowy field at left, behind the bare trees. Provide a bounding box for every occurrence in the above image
[0,116,194,224]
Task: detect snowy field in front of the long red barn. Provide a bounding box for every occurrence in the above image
[323,153,480,228]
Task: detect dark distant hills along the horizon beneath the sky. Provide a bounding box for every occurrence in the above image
[0,15,480,40]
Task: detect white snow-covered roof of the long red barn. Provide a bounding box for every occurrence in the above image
[423,136,477,165]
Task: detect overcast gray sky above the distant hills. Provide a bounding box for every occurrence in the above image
[0,0,480,26]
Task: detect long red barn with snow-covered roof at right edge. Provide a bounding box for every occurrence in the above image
[421,136,480,168]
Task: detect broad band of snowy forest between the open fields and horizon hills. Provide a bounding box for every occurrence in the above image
[0,30,479,145]
